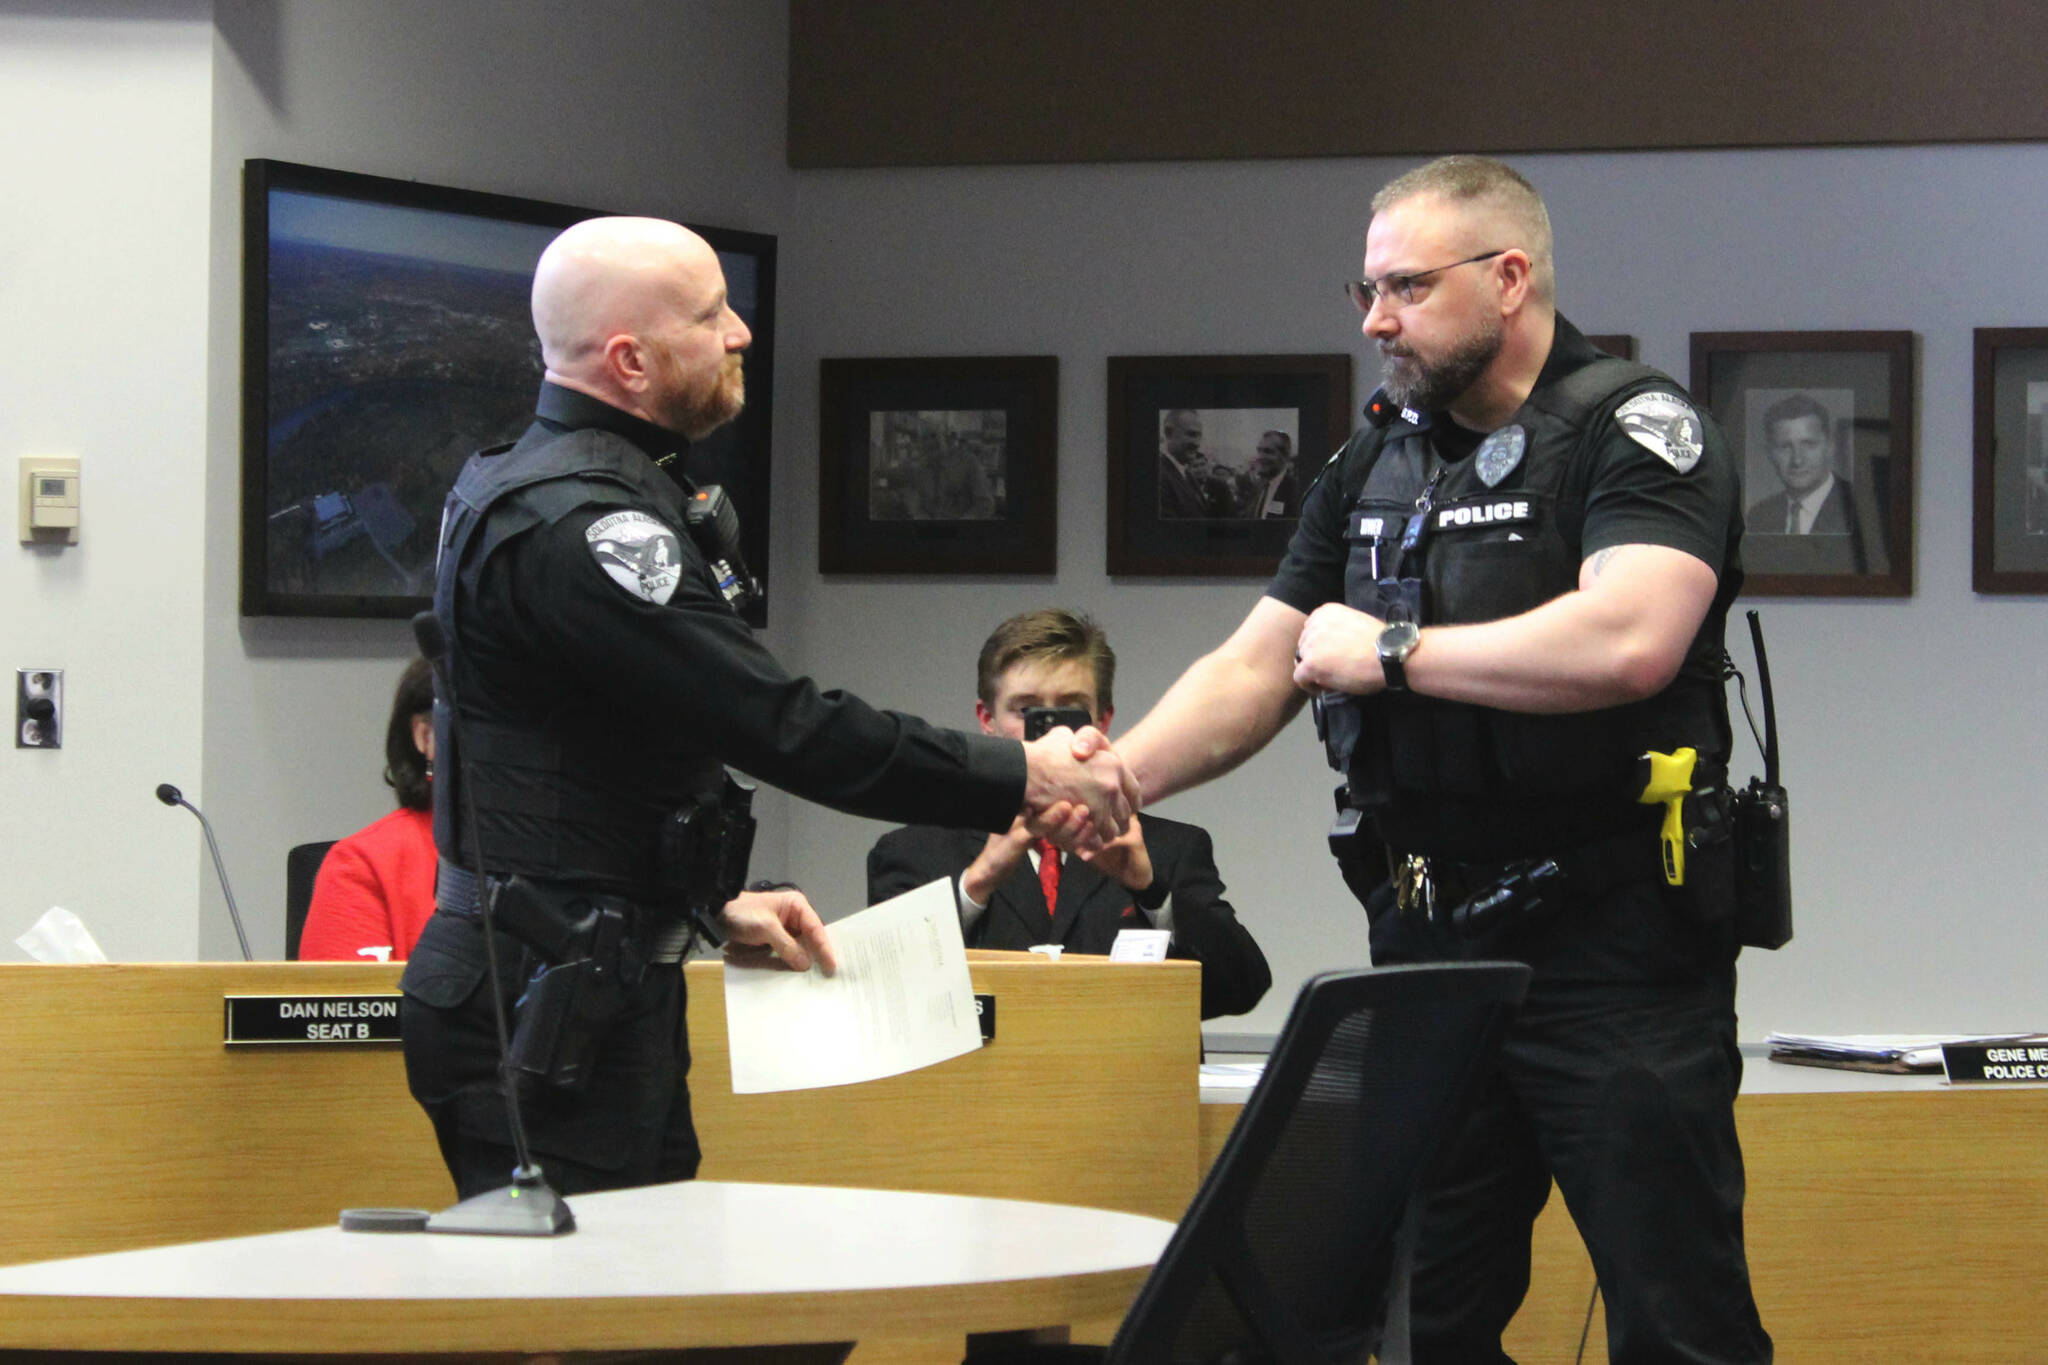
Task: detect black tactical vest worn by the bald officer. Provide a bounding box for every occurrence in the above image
[434,426,723,892]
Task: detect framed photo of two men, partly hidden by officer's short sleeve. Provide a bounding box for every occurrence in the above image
[1108,354,1352,577]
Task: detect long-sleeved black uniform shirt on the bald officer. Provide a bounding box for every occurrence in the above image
[444,385,1024,888]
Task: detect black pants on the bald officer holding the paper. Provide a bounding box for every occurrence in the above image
[399,913,698,1199]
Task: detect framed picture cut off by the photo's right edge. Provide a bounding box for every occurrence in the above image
[1970,327,2048,593]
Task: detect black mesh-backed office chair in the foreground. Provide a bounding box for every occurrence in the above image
[971,962,1530,1365]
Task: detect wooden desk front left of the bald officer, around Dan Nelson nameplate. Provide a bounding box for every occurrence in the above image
[0,962,455,1265]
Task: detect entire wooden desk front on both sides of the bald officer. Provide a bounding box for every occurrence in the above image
[0,954,1200,1265]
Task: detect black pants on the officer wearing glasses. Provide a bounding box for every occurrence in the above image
[1370,882,1772,1365]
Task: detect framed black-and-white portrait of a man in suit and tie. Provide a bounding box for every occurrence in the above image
[1692,332,1915,598]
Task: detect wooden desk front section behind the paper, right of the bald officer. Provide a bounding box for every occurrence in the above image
[688,952,1200,1220]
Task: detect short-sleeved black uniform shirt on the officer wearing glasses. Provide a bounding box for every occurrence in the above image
[1266,317,1741,857]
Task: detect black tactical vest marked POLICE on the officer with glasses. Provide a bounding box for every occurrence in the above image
[1343,358,1729,862]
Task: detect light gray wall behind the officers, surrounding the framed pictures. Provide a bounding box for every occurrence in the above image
[0,0,2048,1038]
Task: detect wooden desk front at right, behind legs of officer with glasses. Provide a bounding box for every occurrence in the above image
[1202,1089,2048,1365]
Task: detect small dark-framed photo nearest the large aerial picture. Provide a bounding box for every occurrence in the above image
[817,356,1059,575]
